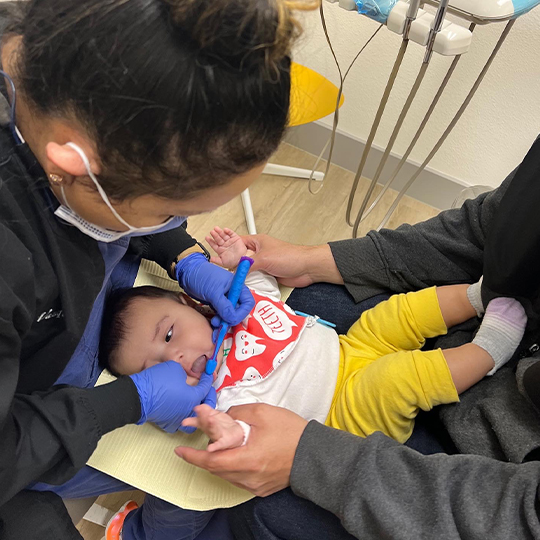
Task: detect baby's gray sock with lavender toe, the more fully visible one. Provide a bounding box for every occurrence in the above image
[472,298,527,375]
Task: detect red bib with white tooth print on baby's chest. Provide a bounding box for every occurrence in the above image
[215,291,307,392]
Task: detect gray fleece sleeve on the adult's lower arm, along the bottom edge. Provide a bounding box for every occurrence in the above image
[291,421,540,540]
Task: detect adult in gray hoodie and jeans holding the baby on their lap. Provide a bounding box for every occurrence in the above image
[178,140,540,540]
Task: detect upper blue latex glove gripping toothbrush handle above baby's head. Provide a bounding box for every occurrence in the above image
[175,253,255,326]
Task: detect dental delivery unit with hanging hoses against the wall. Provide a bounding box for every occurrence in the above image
[321,0,540,238]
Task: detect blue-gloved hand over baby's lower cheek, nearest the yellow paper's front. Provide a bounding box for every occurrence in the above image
[130,360,216,433]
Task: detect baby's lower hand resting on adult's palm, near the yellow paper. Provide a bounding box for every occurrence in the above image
[182,405,244,452]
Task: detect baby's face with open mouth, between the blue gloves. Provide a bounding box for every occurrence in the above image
[115,298,223,384]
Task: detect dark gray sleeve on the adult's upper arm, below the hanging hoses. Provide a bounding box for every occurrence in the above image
[330,171,515,302]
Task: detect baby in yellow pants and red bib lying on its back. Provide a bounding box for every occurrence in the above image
[102,227,527,451]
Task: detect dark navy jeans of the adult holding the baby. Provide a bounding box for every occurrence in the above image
[227,283,444,540]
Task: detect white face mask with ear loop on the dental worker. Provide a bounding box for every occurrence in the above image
[54,142,185,243]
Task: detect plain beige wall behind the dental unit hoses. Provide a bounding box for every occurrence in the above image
[295,0,540,186]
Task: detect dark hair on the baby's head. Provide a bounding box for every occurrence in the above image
[99,285,182,377]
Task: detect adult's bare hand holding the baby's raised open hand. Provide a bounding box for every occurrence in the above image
[242,234,343,287]
